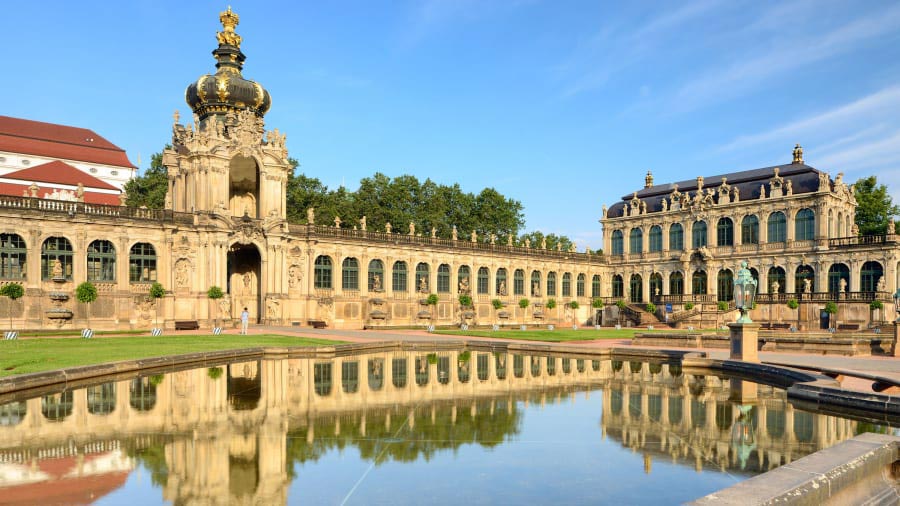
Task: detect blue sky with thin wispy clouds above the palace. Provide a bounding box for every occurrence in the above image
[0,0,900,248]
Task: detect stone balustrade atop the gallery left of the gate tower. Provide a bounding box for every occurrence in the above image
[0,195,194,225]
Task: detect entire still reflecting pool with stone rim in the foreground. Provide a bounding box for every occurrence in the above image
[0,350,889,505]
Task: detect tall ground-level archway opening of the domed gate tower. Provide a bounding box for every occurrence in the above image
[227,244,262,322]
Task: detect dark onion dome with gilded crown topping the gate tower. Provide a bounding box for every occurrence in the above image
[184,7,272,120]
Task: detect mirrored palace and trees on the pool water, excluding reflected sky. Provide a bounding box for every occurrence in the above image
[0,351,880,504]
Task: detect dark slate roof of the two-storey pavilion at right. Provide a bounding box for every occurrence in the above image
[606,163,820,218]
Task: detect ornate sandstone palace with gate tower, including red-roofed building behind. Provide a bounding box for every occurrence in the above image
[0,8,900,329]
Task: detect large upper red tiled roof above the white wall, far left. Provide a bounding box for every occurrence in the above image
[0,116,134,167]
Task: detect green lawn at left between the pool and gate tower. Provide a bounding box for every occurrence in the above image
[0,334,341,377]
